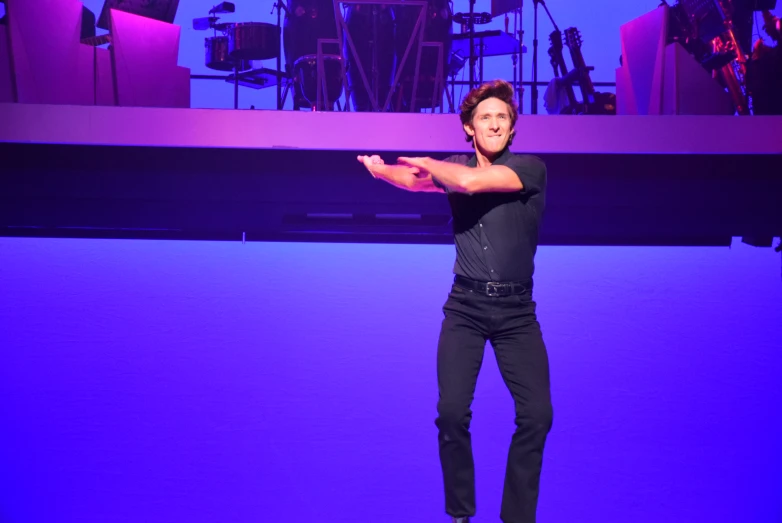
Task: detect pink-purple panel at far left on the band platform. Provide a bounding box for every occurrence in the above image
[6,0,93,104]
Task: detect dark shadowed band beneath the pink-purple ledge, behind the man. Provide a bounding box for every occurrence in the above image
[0,144,782,245]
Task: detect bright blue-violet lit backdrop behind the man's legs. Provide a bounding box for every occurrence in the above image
[0,238,782,523]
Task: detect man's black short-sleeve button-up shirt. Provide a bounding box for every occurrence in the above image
[435,149,547,282]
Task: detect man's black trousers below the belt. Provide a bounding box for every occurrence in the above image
[436,285,553,523]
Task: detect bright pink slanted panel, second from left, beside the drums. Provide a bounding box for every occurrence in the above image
[111,10,190,107]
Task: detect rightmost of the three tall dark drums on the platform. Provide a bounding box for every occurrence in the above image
[393,0,453,112]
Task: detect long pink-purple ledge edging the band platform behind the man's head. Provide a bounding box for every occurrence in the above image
[0,104,782,155]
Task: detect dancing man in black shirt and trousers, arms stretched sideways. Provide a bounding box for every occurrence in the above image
[358,80,552,523]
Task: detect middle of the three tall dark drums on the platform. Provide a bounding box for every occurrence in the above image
[343,4,395,112]
